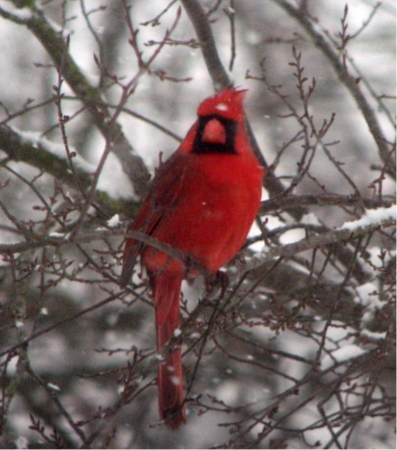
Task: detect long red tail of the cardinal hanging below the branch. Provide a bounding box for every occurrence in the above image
[151,273,186,430]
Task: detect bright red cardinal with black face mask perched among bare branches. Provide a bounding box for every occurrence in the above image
[120,89,263,429]
